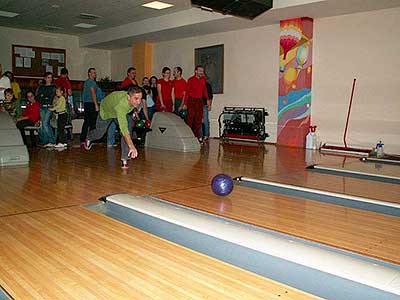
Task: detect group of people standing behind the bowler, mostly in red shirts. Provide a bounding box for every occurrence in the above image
[80,66,213,147]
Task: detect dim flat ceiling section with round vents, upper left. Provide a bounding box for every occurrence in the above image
[0,0,191,35]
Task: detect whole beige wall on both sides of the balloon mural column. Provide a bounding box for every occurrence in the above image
[153,8,400,153]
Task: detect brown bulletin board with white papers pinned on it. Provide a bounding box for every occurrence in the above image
[12,45,67,77]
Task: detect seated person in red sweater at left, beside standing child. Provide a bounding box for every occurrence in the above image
[16,91,40,145]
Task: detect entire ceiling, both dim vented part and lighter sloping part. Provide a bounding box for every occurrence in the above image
[0,0,400,49]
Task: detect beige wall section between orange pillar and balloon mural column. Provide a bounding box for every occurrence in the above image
[153,25,279,141]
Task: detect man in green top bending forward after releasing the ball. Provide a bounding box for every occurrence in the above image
[84,86,142,169]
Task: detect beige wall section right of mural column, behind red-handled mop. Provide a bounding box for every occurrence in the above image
[312,8,400,153]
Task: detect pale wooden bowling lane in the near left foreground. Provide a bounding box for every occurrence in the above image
[0,207,318,300]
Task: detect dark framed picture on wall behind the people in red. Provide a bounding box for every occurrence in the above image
[194,45,224,94]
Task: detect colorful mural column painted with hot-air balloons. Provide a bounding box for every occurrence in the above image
[277,18,313,147]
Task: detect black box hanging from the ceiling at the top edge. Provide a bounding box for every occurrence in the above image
[191,0,272,20]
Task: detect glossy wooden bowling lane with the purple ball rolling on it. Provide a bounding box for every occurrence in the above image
[153,186,400,264]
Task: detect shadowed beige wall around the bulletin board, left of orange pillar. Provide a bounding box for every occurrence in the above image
[0,27,111,80]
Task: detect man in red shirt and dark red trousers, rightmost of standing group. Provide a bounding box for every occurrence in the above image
[184,65,209,142]
